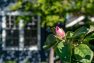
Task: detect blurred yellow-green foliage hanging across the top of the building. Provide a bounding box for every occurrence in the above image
[10,0,94,26]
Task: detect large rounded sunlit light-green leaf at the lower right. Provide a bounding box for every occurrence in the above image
[74,44,93,63]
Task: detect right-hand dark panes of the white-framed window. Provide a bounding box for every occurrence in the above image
[24,22,37,47]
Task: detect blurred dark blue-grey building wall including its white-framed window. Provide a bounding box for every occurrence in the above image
[0,0,47,63]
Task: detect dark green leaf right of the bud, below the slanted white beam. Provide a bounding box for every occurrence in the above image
[73,26,88,38]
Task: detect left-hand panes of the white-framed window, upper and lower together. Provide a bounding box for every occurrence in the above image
[5,16,19,47]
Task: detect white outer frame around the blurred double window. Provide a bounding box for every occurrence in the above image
[0,11,41,50]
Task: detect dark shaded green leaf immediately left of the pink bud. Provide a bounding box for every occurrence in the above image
[43,34,57,49]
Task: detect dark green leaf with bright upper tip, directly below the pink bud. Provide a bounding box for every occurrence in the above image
[55,42,71,63]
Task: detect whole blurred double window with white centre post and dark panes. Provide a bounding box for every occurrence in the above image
[2,12,39,50]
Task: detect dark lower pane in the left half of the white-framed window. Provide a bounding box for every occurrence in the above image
[5,29,19,47]
